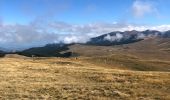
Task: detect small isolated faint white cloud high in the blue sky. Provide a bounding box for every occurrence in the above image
[132,0,157,17]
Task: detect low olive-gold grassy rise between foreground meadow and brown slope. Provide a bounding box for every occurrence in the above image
[82,54,170,72]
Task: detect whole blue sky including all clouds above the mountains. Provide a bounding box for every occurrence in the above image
[0,0,170,49]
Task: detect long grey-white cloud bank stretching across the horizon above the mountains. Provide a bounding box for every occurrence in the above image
[0,22,170,48]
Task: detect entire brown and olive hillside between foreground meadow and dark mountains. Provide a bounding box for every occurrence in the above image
[69,37,170,71]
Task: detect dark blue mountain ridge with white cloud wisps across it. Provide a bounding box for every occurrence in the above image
[87,30,165,46]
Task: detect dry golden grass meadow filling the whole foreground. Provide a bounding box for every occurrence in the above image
[0,57,170,100]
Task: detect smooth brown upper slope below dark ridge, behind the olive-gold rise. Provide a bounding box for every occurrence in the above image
[69,37,170,60]
